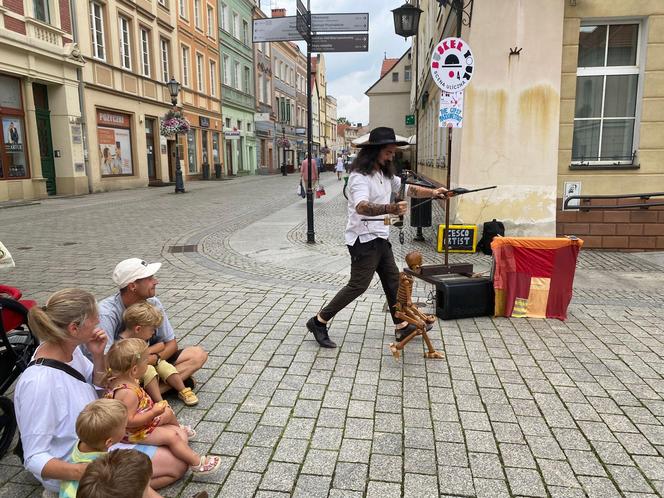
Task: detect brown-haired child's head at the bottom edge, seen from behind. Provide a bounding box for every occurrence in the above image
[76,450,153,498]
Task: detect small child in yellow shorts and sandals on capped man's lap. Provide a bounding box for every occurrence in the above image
[120,301,198,406]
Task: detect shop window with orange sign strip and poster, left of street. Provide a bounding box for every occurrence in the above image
[97,110,134,177]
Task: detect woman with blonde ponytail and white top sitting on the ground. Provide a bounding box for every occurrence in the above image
[14,289,187,491]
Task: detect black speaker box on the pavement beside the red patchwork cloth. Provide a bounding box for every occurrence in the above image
[436,277,494,320]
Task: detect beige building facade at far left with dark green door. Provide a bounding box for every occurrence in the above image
[0,0,88,202]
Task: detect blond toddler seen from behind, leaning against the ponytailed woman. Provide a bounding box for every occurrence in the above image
[60,399,127,498]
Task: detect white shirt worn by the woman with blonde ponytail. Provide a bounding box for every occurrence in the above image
[14,348,97,492]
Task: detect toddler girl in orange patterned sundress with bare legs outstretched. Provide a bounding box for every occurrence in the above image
[103,338,221,474]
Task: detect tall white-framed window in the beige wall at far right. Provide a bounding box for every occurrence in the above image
[572,23,640,164]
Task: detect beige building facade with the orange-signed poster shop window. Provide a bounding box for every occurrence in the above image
[73,0,183,193]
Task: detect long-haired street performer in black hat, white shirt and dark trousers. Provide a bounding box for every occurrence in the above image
[307,127,453,348]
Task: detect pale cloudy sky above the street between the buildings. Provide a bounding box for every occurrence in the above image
[261,0,410,125]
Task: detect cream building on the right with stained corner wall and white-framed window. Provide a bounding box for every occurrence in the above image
[411,0,664,249]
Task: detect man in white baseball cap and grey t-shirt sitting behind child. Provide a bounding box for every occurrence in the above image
[99,258,208,392]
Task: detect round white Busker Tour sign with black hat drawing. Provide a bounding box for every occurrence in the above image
[431,37,475,93]
